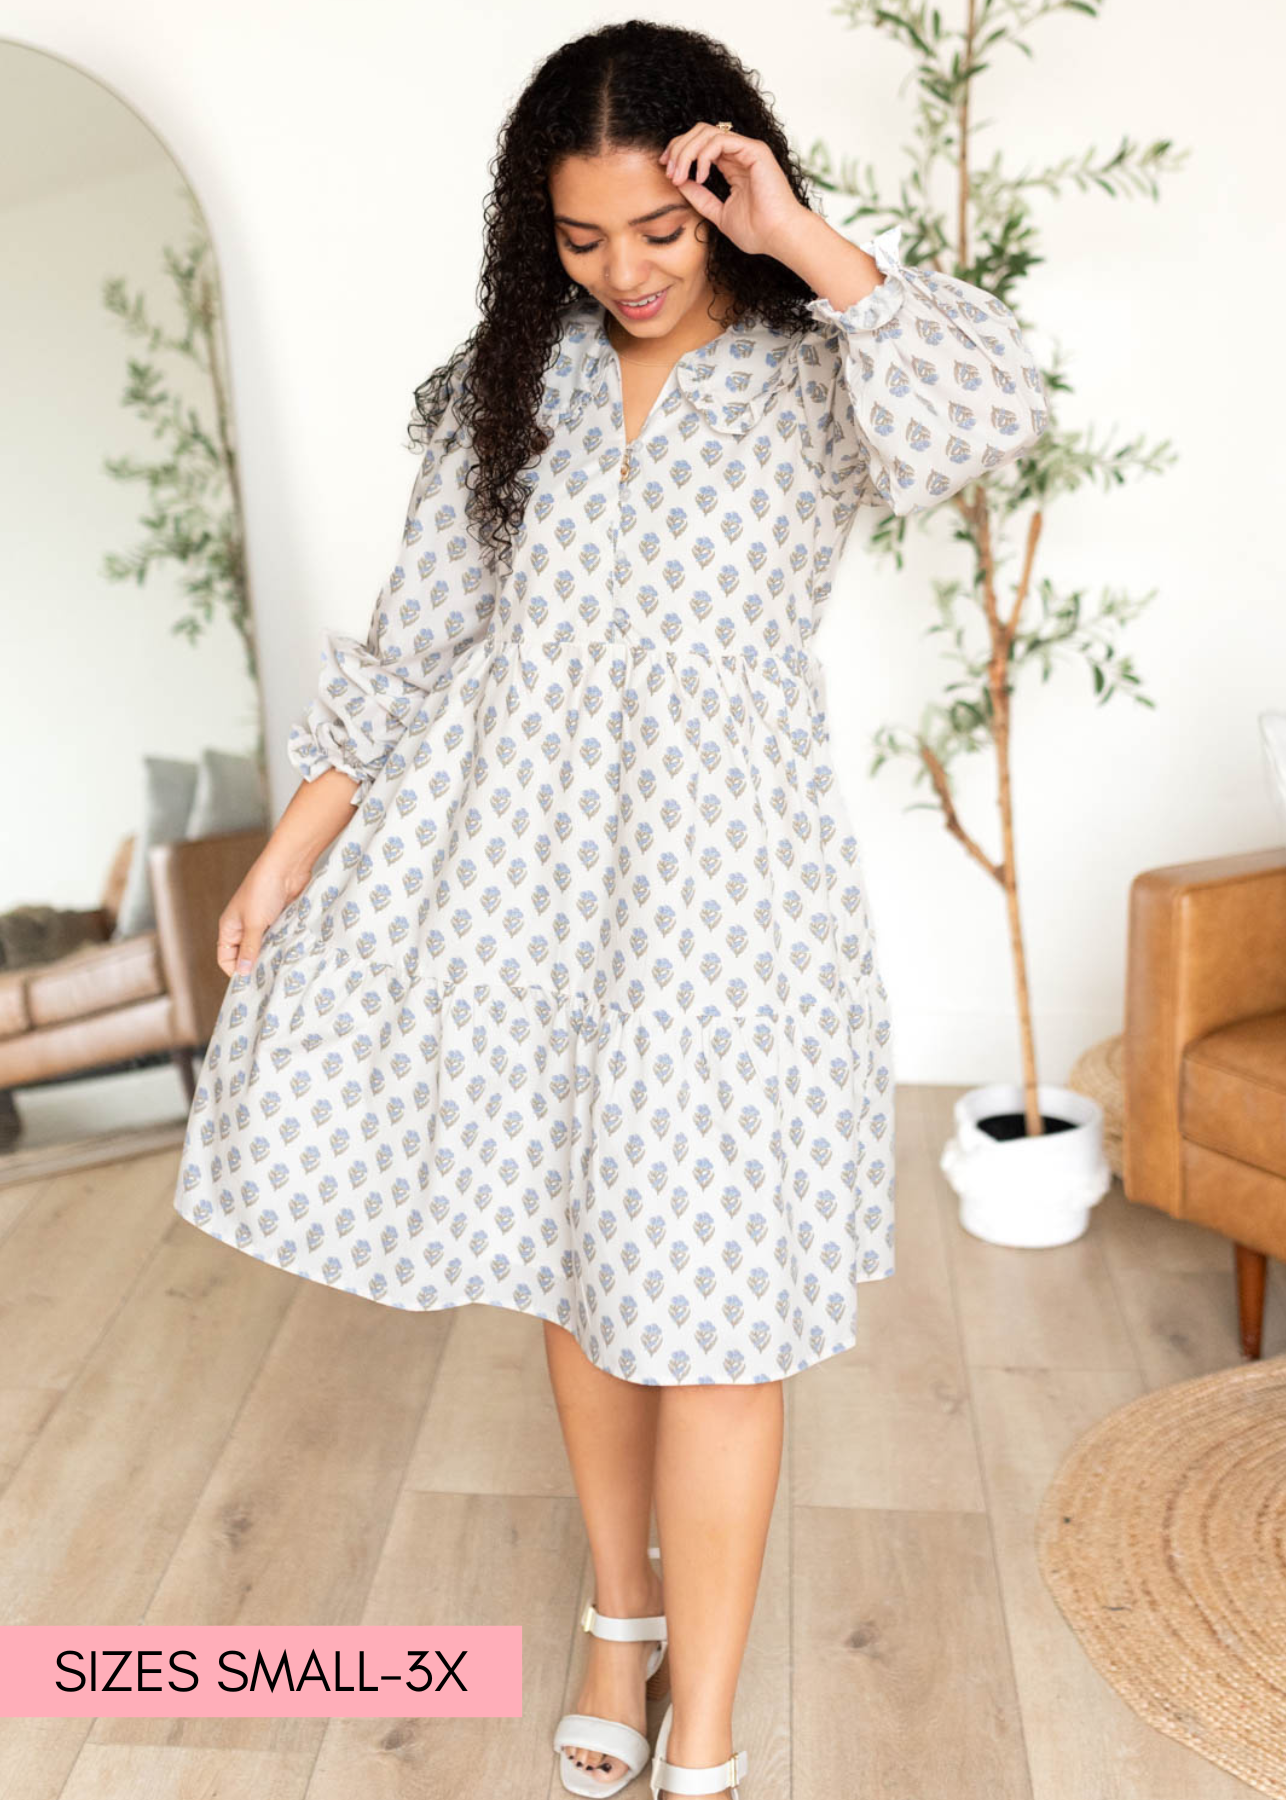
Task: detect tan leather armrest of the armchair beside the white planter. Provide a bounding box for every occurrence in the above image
[1122,846,1286,1215]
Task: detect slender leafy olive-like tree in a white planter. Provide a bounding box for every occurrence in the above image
[807,0,1183,1246]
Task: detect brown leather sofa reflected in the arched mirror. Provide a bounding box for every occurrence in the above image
[0,828,268,1141]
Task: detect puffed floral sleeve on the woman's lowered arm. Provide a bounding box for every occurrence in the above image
[286,345,495,806]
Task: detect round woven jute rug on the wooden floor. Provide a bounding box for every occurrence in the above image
[1036,1355,1286,1800]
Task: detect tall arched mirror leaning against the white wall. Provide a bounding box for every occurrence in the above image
[0,43,268,1181]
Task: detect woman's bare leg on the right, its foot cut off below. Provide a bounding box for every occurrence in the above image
[656,1381,783,1796]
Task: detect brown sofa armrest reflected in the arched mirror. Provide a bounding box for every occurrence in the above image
[148,828,268,1048]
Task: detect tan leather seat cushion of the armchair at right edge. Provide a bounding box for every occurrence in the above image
[1180,1012,1286,1177]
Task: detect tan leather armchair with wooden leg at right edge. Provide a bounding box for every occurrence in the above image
[1124,848,1286,1357]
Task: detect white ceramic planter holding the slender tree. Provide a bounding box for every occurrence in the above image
[940,1082,1111,1249]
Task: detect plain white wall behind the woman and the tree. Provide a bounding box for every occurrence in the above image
[0,0,1286,1082]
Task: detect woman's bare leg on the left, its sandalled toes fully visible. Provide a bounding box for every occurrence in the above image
[544,1319,668,1784]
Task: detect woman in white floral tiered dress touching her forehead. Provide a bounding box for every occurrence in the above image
[175,22,1045,1796]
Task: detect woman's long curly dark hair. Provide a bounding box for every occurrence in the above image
[407,18,832,567]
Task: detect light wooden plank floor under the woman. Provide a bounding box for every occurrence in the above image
[0,1087,1267,1800]
